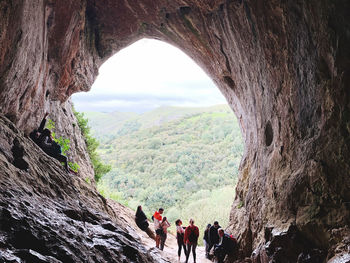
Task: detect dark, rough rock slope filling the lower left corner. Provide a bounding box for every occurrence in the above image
[0,116,168,263]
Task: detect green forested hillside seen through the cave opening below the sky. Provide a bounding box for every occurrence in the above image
[85,105,243,241]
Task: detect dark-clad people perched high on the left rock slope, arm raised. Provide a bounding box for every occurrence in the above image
[29,113,74,173]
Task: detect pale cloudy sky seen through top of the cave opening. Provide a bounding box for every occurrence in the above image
[72,39,227,113]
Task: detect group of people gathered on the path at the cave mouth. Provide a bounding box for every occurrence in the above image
[135,206,236,263]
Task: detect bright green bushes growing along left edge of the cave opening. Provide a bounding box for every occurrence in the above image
[73,109,111,182]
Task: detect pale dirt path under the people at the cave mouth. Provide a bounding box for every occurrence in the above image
[108,200,212,263]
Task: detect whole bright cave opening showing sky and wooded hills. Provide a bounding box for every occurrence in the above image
[72,39,243,240]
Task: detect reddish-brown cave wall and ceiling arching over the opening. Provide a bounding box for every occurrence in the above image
[0,0,350,262]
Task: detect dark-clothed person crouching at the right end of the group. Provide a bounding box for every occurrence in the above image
[214,228,237,263]
